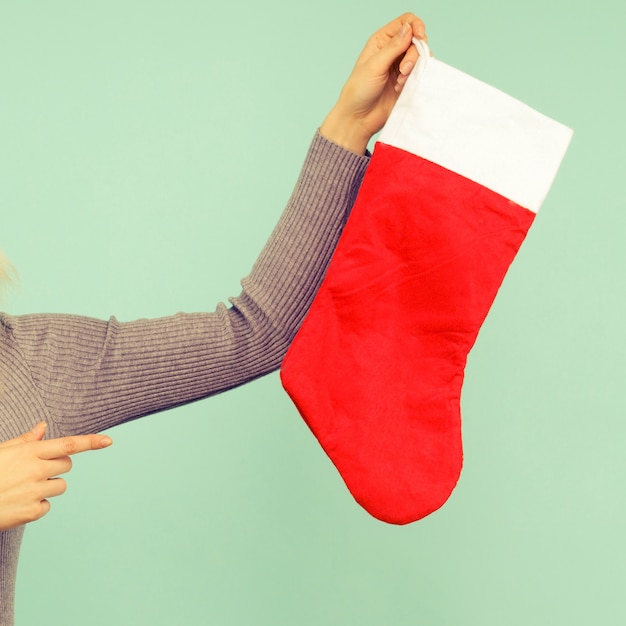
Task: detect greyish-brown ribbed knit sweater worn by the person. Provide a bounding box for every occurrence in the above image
[0,134,368,626]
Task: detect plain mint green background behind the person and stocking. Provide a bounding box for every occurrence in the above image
[0,0,626,626]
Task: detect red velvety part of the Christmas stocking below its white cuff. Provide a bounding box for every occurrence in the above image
[281,143,534,524]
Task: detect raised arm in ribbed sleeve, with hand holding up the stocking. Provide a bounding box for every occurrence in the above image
[5,14,424,436]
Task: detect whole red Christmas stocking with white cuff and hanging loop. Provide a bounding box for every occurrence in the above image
[281,41,571,524]
